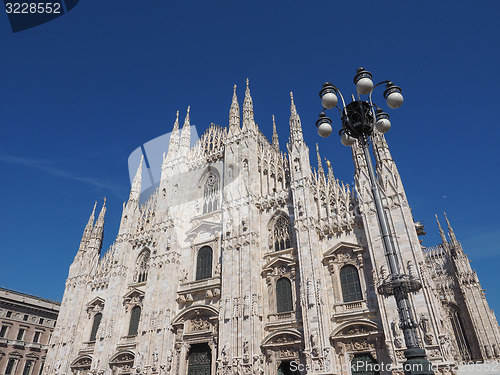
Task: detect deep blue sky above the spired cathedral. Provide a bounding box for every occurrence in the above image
[0,0,500,313]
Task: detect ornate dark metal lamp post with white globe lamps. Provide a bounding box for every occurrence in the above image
[316,68,434,375]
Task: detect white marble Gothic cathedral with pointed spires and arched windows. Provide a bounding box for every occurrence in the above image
[44,82,500,375]
